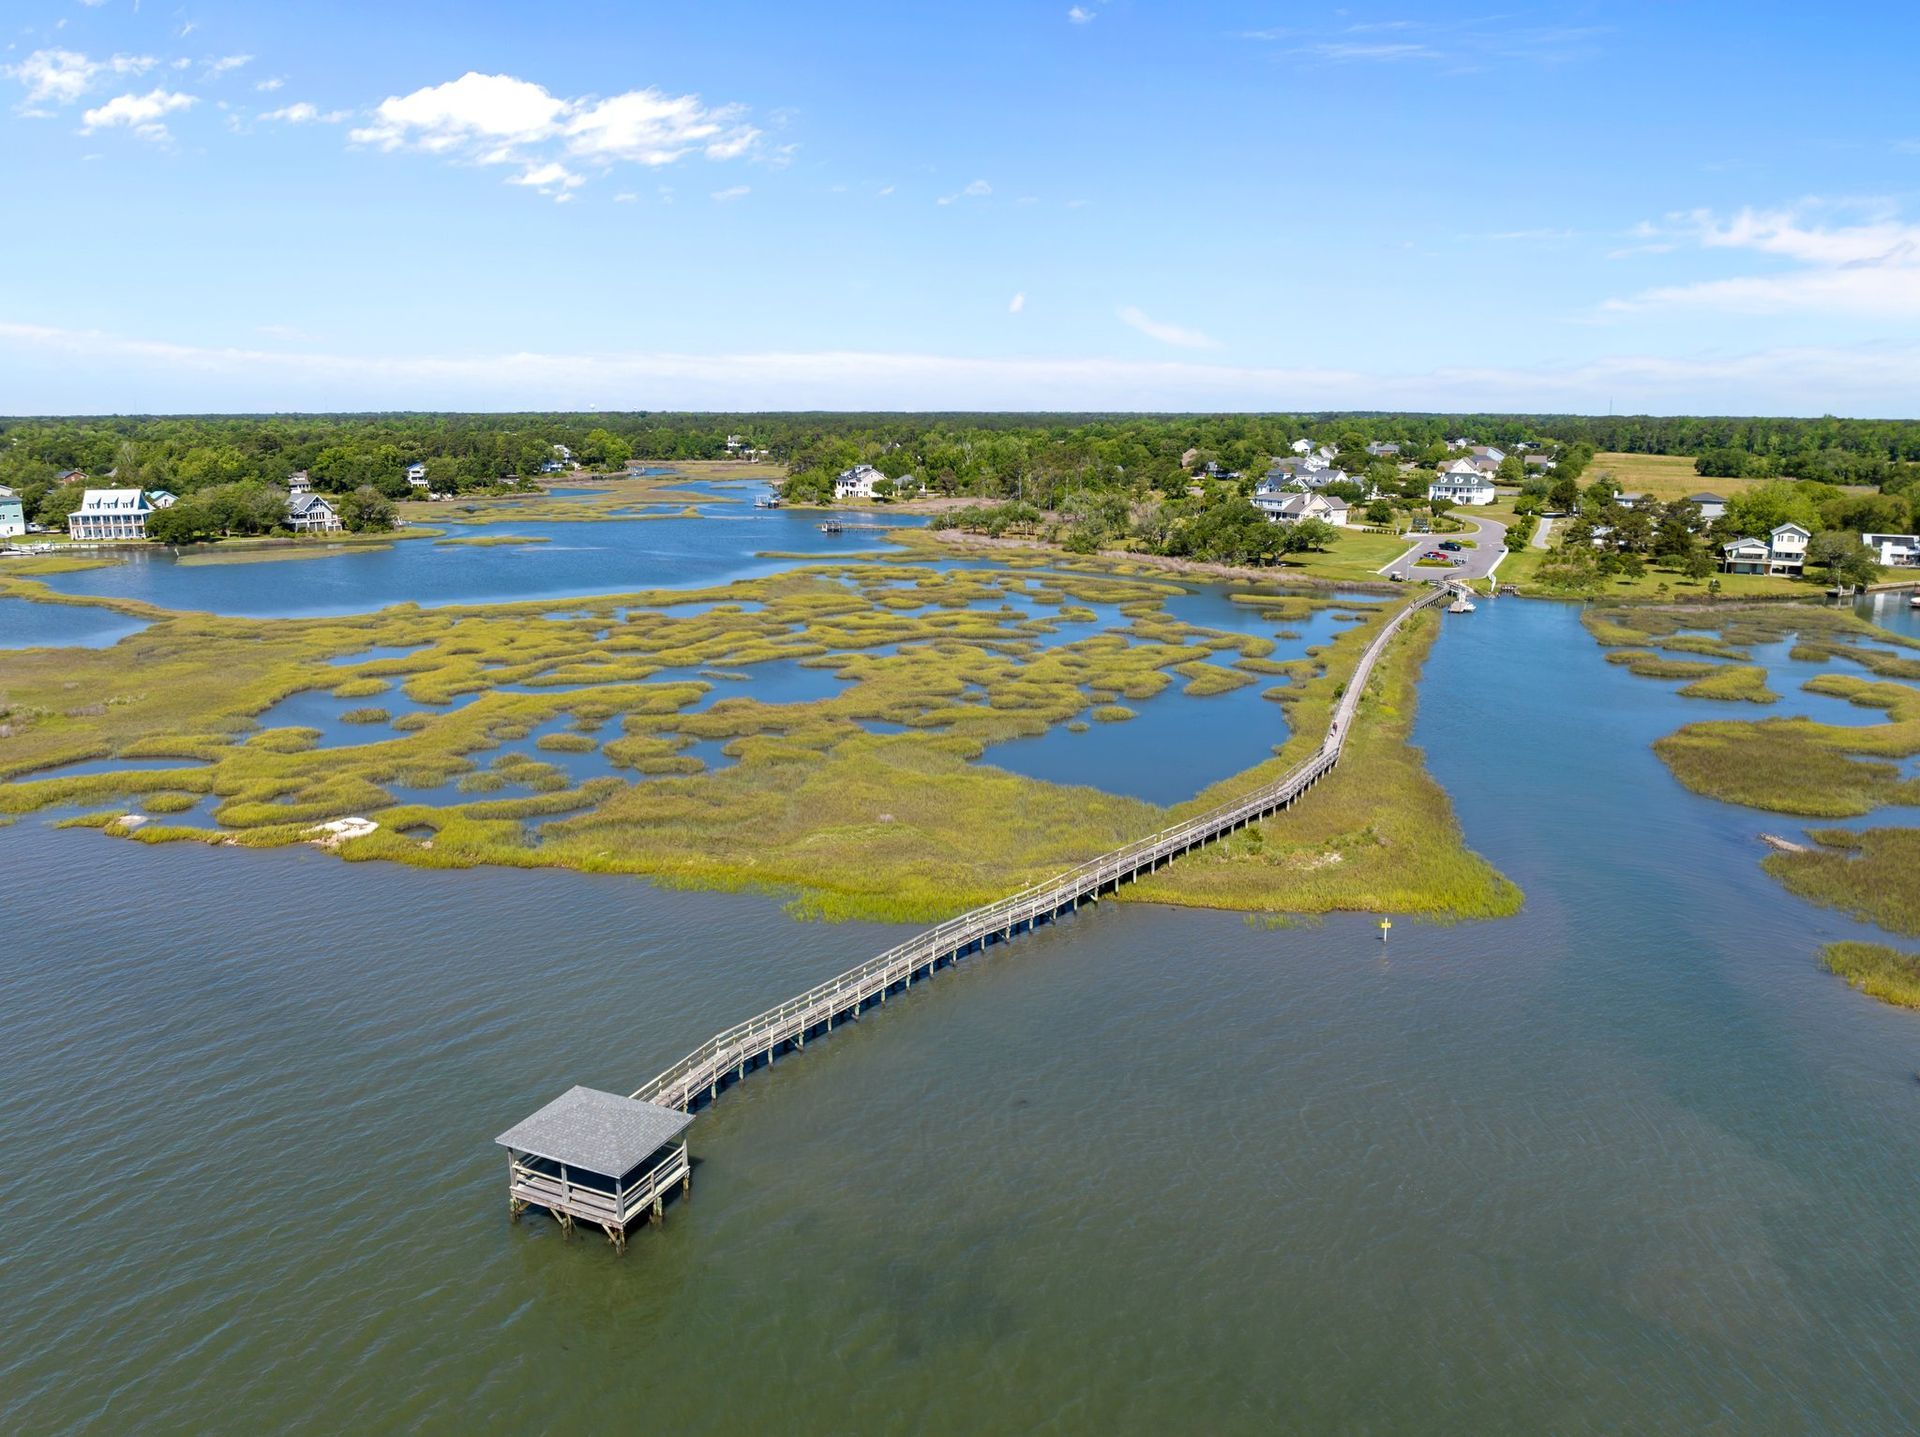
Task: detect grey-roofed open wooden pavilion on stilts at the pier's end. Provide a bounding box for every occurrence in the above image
[493,1087,693,1251]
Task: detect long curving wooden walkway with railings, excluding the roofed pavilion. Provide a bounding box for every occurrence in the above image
[634,588,1448,1110]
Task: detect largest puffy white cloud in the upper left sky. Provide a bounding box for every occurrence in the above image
[349,71,760,194]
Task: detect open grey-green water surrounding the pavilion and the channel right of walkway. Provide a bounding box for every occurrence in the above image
[0,537,1920,1433]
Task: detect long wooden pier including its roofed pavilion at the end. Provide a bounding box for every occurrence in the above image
[495,588,1450,1251]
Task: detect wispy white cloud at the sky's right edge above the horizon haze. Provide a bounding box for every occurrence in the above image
[1605,200,1920,317]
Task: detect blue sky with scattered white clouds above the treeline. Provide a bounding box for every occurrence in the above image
[0,0,1920,417]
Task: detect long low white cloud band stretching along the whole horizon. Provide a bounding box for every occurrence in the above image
[0,323,1920,415]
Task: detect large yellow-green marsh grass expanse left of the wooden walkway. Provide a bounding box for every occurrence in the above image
[0,549,1420,920]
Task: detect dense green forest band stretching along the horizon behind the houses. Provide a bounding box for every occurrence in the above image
[0,413,1920,557]
